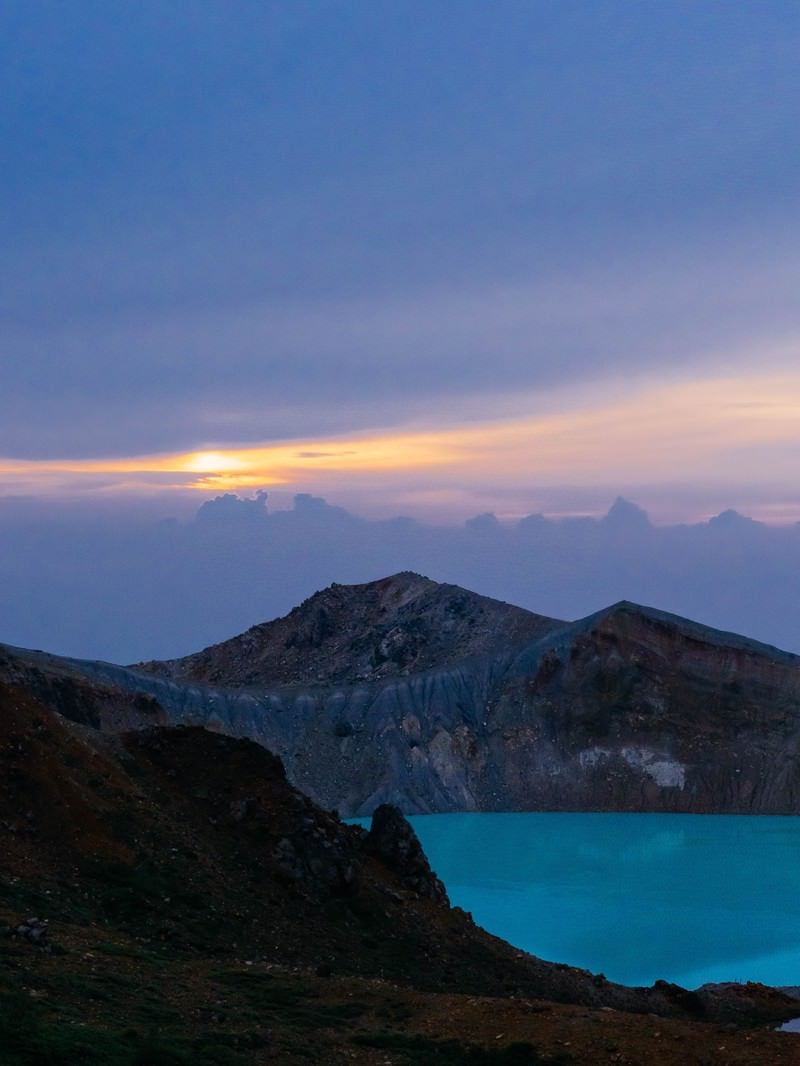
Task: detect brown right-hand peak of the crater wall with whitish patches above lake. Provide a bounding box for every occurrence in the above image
[480,604,800,812]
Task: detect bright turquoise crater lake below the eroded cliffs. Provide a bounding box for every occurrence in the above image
[373,813,800,988]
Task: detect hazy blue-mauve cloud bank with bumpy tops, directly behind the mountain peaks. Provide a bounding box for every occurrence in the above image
[0,494,800,662]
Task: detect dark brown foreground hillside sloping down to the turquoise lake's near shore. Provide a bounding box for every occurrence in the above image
[0,684,800,1066]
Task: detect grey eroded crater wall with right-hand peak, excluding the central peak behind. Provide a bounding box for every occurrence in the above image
[1,584,800,815]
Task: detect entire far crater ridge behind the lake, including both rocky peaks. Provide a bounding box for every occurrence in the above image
[0,575,800,814]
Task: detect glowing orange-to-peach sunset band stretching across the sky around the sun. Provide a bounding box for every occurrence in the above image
[0,373,800,515]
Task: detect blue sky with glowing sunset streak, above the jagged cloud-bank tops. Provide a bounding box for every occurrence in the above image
[0,0,800,523]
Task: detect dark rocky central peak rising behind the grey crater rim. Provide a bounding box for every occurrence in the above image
[137,571,563,688]
